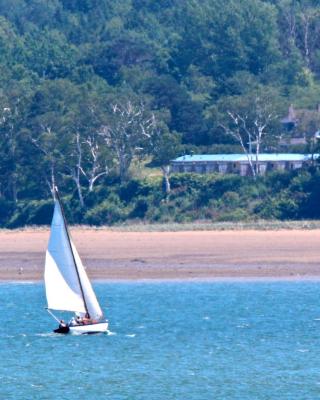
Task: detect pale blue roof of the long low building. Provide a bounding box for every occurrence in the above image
[173,153,319,162]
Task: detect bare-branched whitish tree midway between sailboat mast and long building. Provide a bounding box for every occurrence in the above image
[100,101,156,181]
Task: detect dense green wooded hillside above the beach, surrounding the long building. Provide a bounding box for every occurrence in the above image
[0,0,320,228]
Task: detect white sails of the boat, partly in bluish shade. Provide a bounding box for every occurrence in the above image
[44,193,103,319]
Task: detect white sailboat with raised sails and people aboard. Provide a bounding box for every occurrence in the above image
[44,188,108,334]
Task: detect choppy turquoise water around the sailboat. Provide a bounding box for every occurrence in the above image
[0,282,320,400]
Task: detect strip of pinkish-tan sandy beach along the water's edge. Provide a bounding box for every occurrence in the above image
[0,228,320,281]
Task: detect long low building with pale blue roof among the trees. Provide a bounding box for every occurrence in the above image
[171,153,318,176]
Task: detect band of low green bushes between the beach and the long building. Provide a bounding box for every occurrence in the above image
[0,168,320,228]
